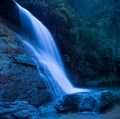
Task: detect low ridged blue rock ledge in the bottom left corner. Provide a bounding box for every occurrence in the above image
[0,101,42,119]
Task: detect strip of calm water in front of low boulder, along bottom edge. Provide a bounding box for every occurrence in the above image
[43,105,120,119]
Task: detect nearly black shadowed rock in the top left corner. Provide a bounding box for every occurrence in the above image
[0,0,21,31]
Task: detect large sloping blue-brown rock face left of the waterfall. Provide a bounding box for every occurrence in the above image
[0,18,51,106]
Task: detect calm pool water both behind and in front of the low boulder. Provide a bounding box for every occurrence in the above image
[42,86,120,119]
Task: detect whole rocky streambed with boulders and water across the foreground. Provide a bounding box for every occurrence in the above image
[0,90,120,119]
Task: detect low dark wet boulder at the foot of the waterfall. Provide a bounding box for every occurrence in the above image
[54,91,120,113]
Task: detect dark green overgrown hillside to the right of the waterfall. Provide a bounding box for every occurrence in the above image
[0,0,120,90]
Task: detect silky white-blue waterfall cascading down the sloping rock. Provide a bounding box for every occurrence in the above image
[16,3,89,96]
